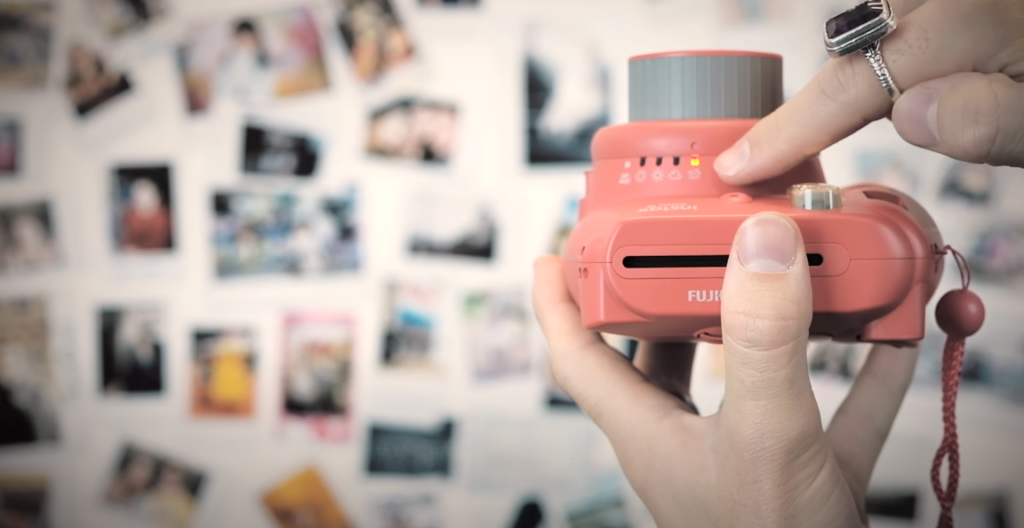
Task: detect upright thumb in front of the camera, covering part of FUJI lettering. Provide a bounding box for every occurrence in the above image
[722,213,820,429]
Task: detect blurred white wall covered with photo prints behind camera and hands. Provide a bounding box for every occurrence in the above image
[0,0,1024,528]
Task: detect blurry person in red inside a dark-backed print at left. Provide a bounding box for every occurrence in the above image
[119,178,171,252]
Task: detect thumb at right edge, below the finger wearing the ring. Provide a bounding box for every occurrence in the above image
[892,73,1024,167]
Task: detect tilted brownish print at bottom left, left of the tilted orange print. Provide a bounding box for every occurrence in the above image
[103,444,207,528]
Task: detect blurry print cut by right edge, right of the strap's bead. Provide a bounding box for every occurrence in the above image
[967,223,1024,282]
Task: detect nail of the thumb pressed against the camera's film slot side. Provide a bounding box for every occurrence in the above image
[736,215,797,273]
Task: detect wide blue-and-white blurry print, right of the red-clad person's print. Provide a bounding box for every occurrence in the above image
[213,187,360,278]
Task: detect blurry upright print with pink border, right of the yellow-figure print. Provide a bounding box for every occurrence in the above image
[282,312,355,441]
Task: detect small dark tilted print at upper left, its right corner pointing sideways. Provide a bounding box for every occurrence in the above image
[67,43,131,118]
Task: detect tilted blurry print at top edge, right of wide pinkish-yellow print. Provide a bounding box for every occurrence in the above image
[338,0,415,84]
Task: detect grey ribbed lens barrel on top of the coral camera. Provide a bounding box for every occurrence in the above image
[630,51,782,122]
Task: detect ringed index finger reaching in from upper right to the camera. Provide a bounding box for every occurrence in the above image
[715,0,1014,185]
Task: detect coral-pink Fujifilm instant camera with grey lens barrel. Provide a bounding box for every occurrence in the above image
[564,51,943,345]
